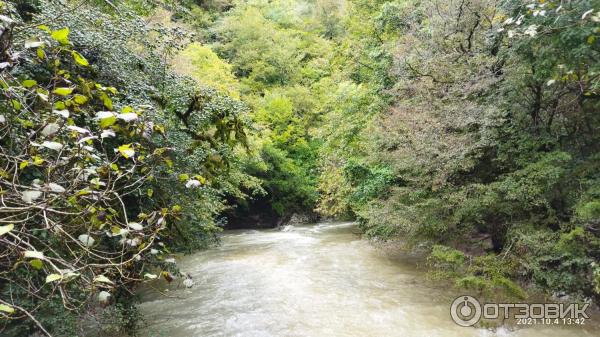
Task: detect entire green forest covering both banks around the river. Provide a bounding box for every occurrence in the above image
[0,0,600,337]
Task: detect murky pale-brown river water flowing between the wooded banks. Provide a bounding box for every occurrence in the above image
[141,223,598,337]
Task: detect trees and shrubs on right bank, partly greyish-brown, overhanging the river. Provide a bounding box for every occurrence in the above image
[312,1,600,298]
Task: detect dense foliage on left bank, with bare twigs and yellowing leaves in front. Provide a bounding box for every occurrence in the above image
[0,1,260,336]
